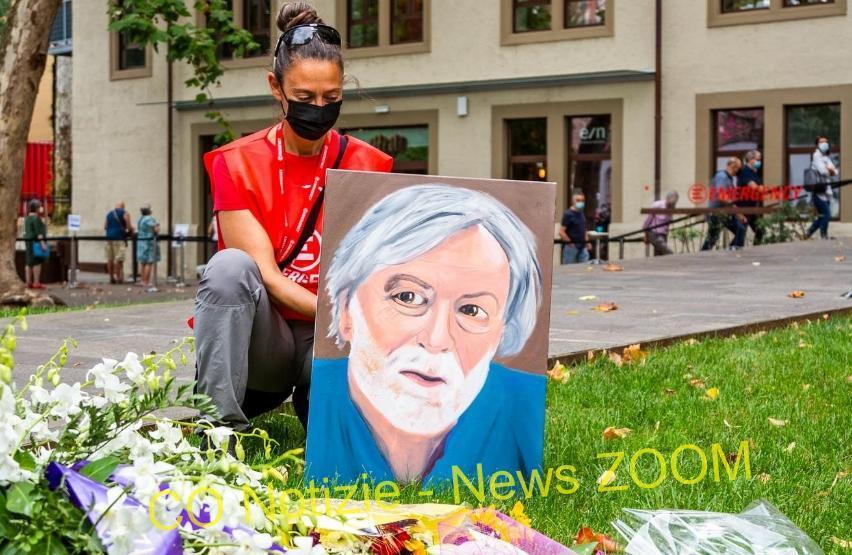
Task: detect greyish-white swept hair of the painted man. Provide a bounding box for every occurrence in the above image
[326,184,542,356]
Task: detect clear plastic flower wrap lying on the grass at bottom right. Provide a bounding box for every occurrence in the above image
[613,501,823,555]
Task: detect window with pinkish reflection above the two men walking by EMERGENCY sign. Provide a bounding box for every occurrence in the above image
[708,108,766,177]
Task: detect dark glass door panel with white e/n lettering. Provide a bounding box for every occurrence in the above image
[566,114,612,221]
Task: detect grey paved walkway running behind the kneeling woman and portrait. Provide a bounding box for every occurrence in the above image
[8,240,852,390]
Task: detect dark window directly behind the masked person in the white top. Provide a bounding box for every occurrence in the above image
[784,104,840,201]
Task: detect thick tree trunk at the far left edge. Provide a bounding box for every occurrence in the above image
[0,0,62,303]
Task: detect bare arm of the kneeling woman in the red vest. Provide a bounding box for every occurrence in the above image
[219,210,317,318]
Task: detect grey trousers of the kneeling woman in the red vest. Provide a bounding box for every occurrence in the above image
[195,249,314,430]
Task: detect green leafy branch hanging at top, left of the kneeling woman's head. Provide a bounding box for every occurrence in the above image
[108,0,260,144]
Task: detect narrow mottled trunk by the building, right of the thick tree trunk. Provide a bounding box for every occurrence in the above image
[53,56,71,225]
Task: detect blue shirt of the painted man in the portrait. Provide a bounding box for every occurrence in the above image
[305,358,546,484]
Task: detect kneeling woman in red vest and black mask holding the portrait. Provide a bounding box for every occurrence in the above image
[193,2,393,430]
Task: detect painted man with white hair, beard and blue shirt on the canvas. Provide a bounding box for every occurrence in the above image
[307,184,545,482]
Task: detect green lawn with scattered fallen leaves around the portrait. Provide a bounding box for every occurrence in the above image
[241,317,852,553]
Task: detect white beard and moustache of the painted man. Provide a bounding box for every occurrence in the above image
[349,296,495,437]
